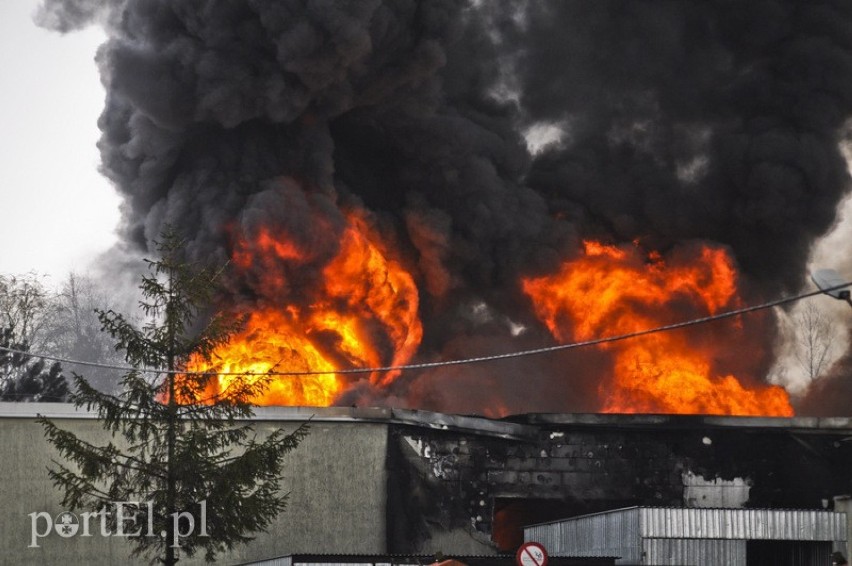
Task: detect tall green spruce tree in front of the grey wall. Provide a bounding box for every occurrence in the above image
[40,233,307,565]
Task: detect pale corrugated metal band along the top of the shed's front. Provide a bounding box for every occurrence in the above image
[639,507,846,541]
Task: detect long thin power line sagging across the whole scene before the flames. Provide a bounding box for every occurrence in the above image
[0,282,852,376]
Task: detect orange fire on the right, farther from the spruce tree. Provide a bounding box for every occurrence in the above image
[522,242,793,416]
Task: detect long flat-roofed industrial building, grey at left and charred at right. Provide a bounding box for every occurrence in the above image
[0,403,852,564]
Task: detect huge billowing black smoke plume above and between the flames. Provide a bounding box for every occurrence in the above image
[39,0,852,418]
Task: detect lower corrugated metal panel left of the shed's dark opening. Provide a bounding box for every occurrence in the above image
[640,538,746,566]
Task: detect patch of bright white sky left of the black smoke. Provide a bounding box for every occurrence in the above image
[0,0,119,282]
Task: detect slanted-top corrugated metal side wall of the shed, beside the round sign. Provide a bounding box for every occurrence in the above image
[524,507,640,563]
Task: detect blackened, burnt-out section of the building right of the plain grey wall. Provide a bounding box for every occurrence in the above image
[388,415,852,552]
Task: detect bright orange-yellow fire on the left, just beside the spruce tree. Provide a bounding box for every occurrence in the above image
[190,212,423,406]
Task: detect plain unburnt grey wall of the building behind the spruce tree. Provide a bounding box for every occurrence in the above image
[0,412,387,565]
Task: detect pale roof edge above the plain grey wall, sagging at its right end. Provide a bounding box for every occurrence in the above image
[0,402,539,440]
